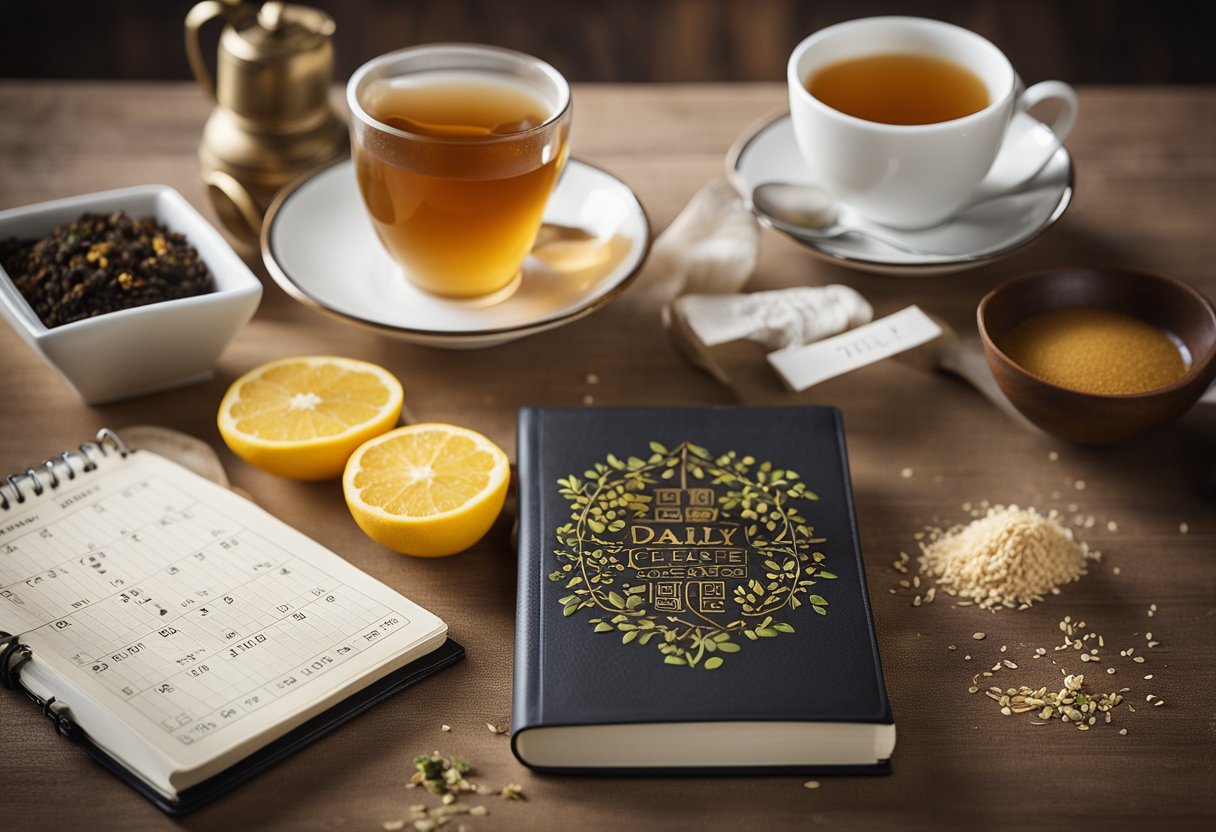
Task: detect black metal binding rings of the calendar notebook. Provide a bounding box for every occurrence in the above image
[0,428,130,738]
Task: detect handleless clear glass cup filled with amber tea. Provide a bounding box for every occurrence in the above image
[347,44,572,304]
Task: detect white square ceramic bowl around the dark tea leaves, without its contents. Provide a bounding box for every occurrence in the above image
[0,185,261,404]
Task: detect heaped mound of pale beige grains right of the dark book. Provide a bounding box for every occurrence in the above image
[919,506,1100,611]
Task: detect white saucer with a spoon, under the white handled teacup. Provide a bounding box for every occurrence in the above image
[726,113,1073,275]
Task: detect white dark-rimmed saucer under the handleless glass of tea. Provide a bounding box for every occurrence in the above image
[261,159,651,349]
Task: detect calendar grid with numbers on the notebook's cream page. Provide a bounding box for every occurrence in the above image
[0,464,428,746]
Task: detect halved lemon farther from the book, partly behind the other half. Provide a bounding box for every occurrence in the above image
[216,355,404,479]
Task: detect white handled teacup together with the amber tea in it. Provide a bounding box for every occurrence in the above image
[787,17,1077,229]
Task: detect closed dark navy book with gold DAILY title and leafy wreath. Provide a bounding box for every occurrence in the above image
[511,407,895,774]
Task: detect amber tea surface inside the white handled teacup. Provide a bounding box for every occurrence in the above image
[806,54,991,124]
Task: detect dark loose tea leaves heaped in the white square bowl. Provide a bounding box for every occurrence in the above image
[0,210,214,327]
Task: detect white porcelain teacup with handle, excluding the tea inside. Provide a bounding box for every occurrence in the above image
[788,17,1077,229]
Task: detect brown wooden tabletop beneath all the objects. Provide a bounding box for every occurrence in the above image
[0,83,1216,832]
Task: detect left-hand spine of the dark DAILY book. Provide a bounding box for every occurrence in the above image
[511,407,544,761]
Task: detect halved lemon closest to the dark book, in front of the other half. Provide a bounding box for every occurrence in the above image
[342,423,511,557]
